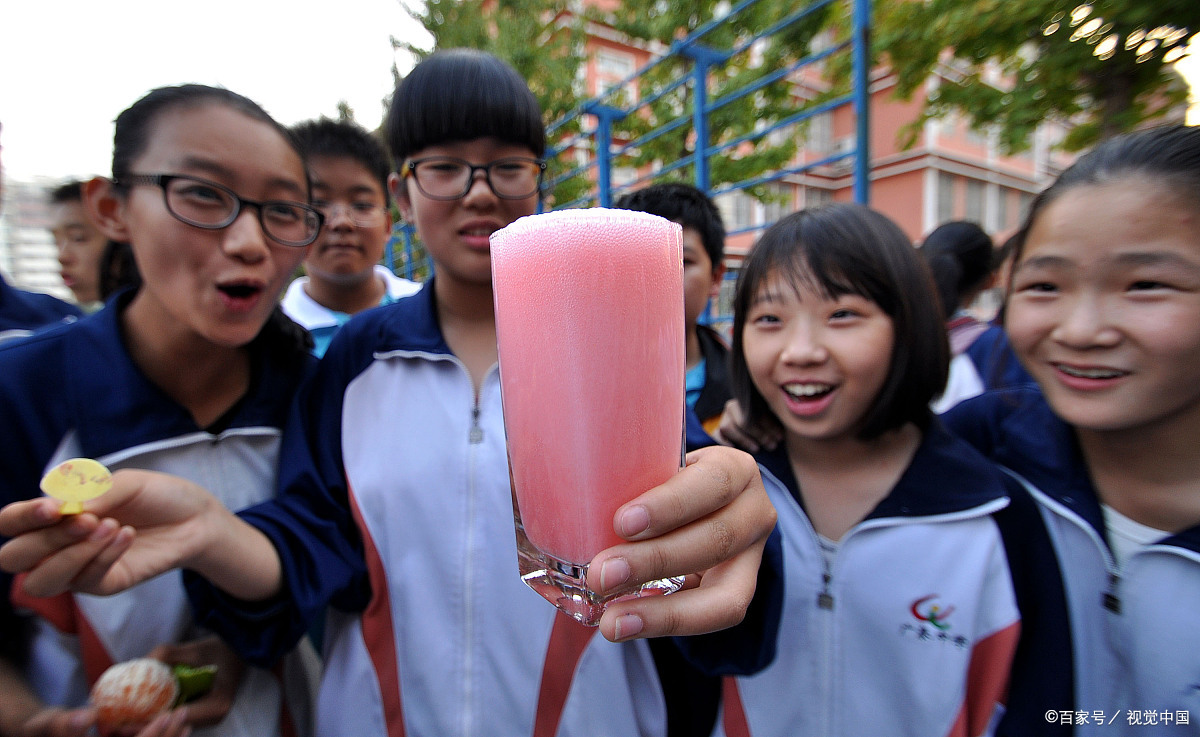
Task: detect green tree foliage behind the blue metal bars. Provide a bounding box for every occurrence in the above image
[594,0,829,199]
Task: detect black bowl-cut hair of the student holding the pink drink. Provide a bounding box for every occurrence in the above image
[384,48,546,170]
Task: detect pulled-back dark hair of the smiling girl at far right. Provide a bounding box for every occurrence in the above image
[1009,125,1200,286]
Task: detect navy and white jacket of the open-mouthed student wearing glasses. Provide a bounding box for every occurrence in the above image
[0,293,312,737]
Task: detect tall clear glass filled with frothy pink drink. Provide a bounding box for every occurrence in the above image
[491,208,684,624]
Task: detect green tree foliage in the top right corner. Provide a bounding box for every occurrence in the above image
[872,0,1200,151]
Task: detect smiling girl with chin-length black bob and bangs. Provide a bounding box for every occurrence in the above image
[724,204,1070,737]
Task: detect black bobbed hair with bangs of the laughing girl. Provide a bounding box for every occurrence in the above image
[730,203,949,439]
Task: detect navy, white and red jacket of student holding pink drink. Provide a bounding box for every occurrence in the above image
[192,282,665,737]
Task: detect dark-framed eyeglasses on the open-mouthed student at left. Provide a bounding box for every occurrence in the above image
[114,174,324,247]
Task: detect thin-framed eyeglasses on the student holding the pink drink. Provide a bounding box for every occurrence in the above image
[402,156,546,200]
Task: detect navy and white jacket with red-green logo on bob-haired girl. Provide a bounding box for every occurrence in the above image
[724,421,1072,737]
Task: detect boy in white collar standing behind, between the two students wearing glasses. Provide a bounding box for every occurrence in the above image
[282,119,420,356]
